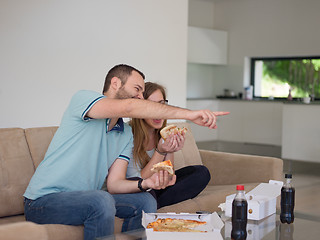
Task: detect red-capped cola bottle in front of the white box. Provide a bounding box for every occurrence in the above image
[231,185,248,240]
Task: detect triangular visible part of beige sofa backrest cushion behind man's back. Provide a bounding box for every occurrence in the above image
[25,127,58,168]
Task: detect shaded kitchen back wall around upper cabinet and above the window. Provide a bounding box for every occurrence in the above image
[188,0,320,97]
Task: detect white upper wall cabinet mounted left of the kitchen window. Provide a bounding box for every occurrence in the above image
[188,27,228,64]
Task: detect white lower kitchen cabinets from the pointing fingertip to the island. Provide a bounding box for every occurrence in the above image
[218,100,282,146]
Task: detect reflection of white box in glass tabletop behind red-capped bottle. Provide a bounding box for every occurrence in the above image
[224,211,277,240]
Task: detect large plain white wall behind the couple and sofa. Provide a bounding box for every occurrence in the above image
[0,0,188,127]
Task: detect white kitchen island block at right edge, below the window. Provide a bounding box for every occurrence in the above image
[281,104,320,163]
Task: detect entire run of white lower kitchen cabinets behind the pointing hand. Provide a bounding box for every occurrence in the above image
[187,99,283,146]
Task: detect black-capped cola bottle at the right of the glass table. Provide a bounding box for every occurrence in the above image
[280,174,295,224]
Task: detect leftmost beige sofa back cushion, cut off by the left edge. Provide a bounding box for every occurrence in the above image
[0,128,34,217]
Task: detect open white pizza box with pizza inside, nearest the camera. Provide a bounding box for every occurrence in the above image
[142,212,224,240]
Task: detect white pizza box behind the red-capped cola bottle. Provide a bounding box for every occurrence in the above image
[225,180,283,220]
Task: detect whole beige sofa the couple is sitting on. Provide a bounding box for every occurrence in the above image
[0,123,283,240]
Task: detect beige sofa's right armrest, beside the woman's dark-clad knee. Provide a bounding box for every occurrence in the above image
[199,150,283,185]
